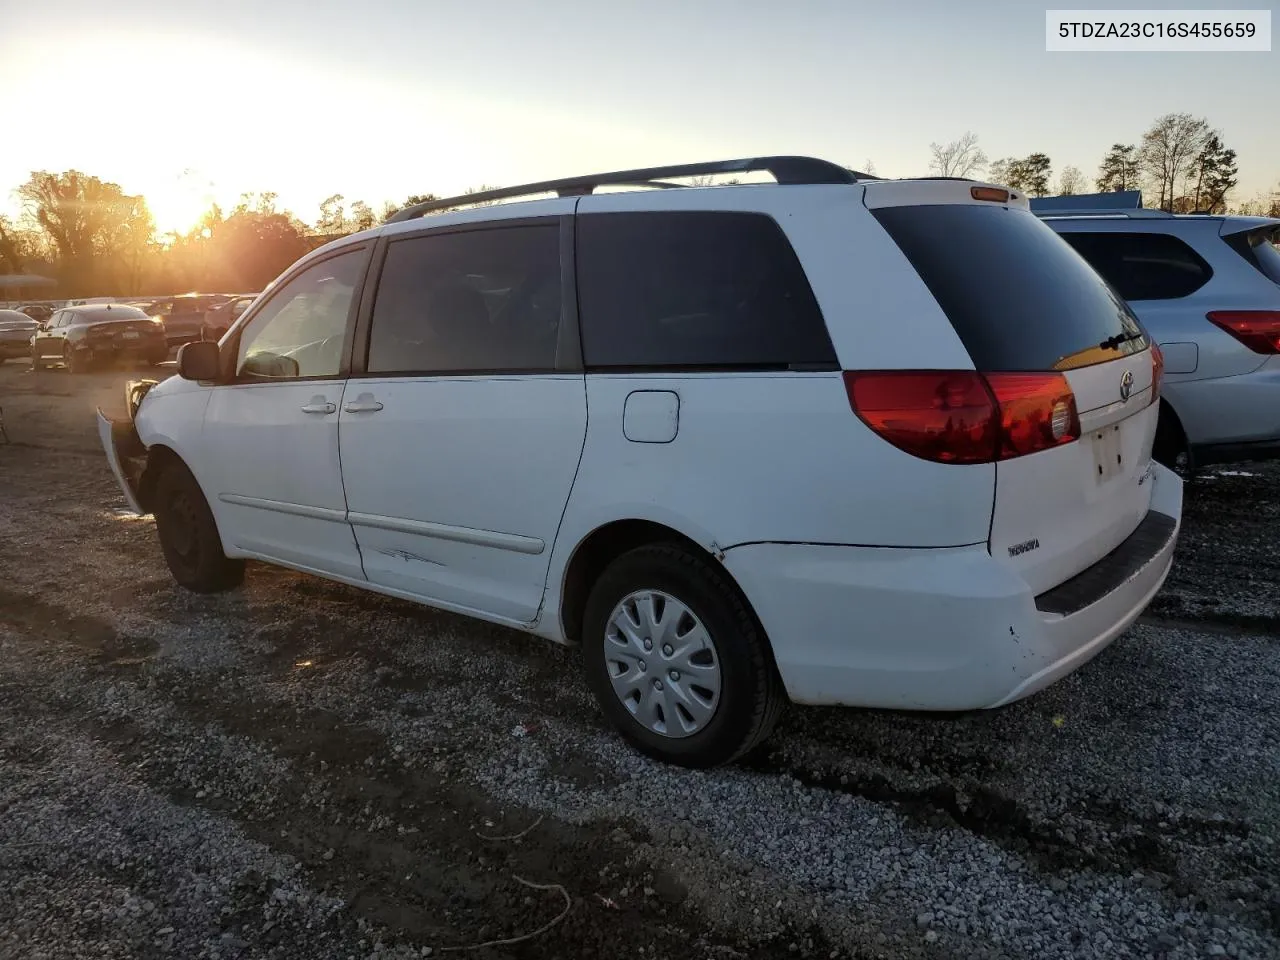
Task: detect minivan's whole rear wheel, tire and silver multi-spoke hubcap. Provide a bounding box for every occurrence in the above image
[582,544,786,767]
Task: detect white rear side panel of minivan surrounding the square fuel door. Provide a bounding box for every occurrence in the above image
[552,374,995,555]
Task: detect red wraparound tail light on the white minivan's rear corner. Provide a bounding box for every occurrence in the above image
[845,370,1080,463]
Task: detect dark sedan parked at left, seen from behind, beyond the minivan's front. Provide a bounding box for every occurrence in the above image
[28,303,169,374]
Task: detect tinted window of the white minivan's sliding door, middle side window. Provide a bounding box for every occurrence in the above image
[369,223,561,374]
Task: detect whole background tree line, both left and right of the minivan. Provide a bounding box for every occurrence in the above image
[0,122,1280,297]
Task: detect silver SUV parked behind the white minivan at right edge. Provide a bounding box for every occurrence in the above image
[1039,209,1280,468]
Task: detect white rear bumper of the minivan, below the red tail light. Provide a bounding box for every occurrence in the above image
[724,465,1183,710]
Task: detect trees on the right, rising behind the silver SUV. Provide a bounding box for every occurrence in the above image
[929,114,1280,216]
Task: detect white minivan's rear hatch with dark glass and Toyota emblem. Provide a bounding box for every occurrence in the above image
[867,183,1160,594]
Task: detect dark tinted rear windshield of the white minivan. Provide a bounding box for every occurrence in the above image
[873,204,1148,372]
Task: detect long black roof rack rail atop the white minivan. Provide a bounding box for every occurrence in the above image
[387,156,881,223]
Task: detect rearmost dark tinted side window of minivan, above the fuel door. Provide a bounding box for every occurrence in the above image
[577,212,836,369]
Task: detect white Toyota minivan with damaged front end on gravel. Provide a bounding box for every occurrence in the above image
[99,157,1181,765]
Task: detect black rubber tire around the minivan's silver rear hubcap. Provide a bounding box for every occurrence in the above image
[582,543,786,768]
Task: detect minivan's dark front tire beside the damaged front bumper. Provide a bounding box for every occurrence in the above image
[154,461,244,594]
